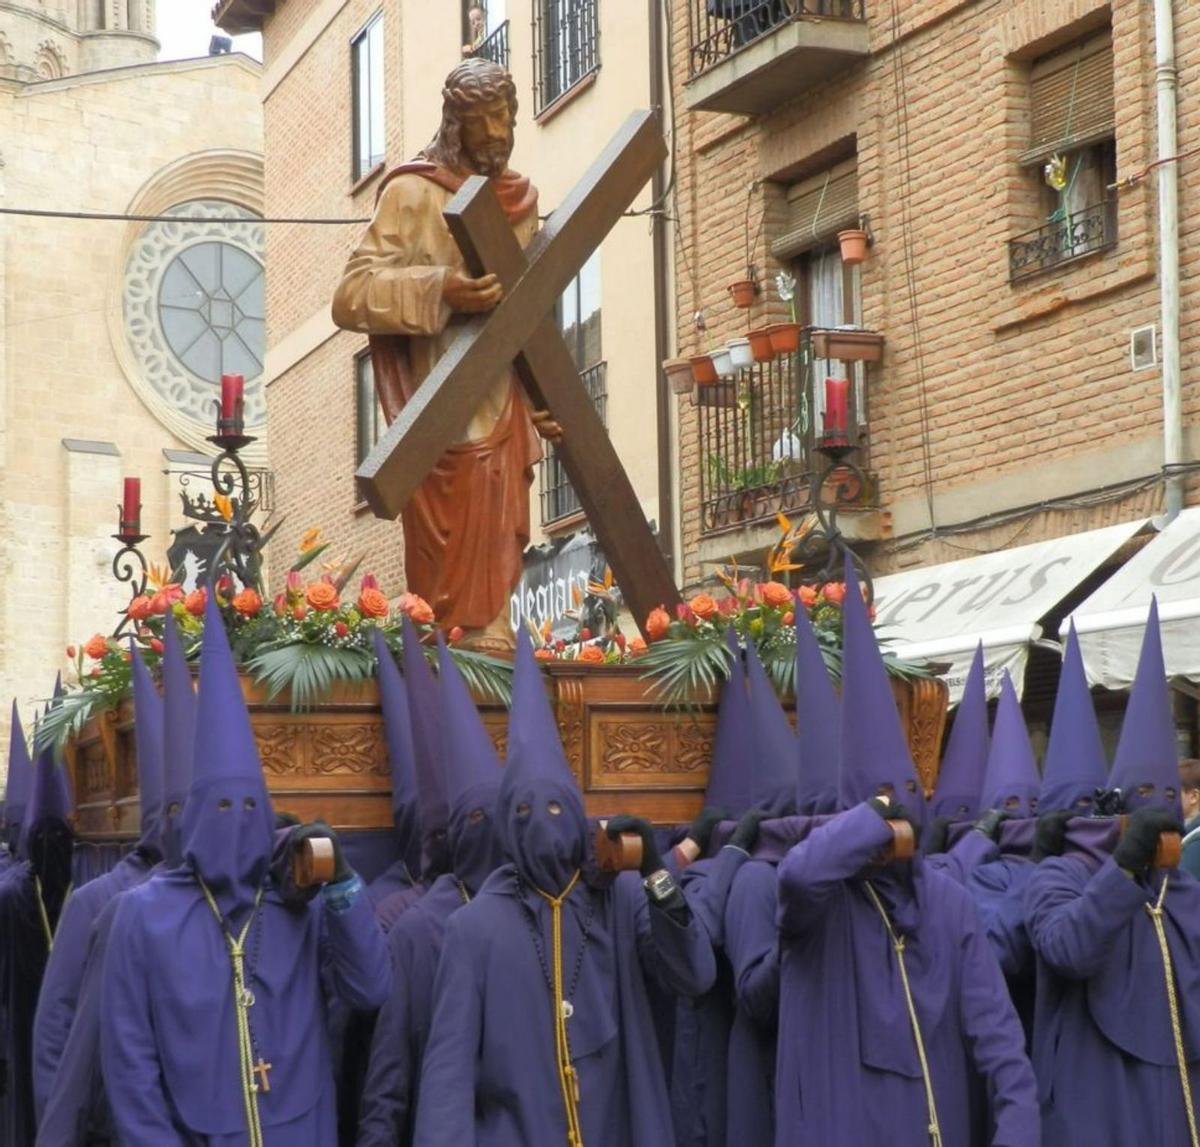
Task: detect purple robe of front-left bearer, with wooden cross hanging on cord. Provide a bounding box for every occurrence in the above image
[101,869,388,1147]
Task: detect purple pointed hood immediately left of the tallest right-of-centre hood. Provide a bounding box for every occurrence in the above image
[796,605,841,816]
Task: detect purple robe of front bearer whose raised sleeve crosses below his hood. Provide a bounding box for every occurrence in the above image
[775,804,1040,1147]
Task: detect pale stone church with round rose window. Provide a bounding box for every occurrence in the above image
[0,0,265,767]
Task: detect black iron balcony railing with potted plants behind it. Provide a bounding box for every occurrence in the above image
[696,331,870,534]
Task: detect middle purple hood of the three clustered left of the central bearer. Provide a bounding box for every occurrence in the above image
[401,614,450,882]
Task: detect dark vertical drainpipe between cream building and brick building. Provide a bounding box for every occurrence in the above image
[648,0,678,577]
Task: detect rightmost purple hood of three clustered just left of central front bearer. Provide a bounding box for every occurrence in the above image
[438,632,503,893]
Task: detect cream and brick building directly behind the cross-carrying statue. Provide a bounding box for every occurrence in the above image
[214,0,674,638]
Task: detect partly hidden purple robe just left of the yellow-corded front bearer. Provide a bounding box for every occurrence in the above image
[358,873,463,1147]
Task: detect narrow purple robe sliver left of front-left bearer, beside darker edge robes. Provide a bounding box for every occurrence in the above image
[34,851,154,1119]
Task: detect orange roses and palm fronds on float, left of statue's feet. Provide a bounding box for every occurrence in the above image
[36,530,512,747]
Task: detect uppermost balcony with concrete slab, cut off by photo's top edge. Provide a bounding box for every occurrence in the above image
[684,0,870,115]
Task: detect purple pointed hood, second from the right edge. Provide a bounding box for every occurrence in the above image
[1038,621,1109,816]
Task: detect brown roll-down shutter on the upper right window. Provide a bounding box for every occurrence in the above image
[1022,31,1116,162]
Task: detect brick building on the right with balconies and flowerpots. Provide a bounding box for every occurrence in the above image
[671,0,1200,734]
